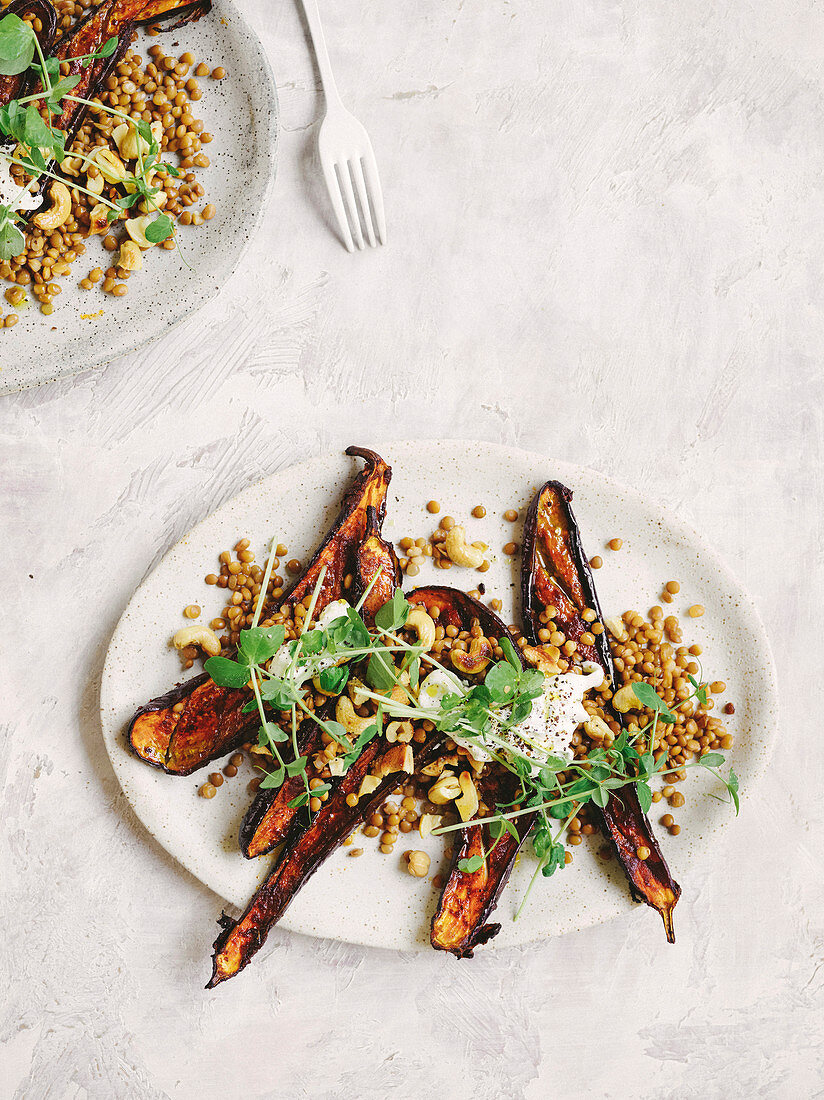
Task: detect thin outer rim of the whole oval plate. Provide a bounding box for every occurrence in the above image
[99,438,780,950]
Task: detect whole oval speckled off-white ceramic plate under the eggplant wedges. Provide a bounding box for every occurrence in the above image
[101,440,777,950]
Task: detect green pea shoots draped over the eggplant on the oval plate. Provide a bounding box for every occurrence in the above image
[205,536,739,897]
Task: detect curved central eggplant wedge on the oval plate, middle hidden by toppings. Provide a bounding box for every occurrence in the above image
[407,585,534,958]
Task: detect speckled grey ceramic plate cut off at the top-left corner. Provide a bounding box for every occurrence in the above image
[0,0,277,394]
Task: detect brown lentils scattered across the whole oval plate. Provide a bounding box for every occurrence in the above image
[182,510,735,887]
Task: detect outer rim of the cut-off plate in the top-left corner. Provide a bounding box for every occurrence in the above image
[0,0,281,398]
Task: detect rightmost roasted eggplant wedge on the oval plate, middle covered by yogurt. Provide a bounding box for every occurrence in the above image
[521,482,681,943]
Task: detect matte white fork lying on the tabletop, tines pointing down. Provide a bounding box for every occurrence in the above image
[300,0,386,252]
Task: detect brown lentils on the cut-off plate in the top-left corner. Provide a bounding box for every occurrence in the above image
[0,0,227,328]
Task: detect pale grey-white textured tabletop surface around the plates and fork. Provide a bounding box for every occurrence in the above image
[0,0,824,1100]
